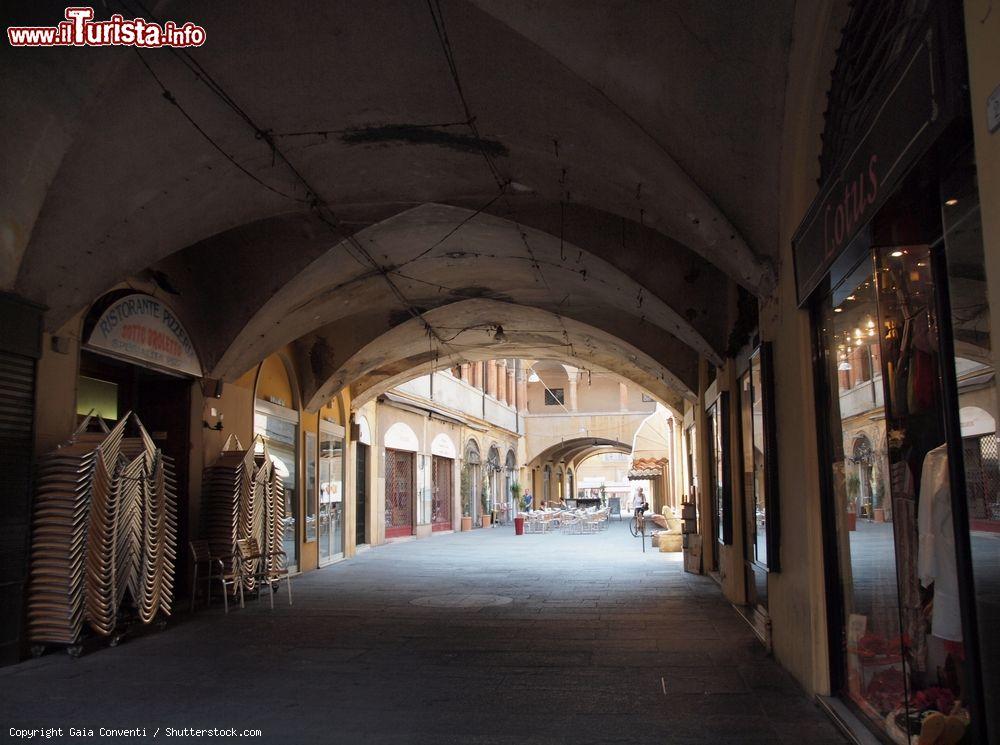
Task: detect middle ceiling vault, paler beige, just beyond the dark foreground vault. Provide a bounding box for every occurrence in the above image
[207,205,719,387]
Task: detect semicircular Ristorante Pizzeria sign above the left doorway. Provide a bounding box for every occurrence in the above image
[86,293,201,377]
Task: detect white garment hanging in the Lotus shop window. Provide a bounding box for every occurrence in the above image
[917,445,962,641]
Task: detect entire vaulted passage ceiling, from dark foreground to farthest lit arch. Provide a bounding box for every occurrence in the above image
[0,0,793,406]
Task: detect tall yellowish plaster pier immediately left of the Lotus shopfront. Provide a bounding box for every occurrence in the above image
[760,0,848,694]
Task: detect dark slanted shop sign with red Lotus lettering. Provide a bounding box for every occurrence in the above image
[792,12,951,305]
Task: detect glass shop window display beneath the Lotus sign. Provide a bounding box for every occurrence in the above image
[813,148,1000,743]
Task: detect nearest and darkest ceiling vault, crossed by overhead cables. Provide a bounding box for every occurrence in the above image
[0,0,792,338]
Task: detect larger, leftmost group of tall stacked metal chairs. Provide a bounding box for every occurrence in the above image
[28,413,177,652]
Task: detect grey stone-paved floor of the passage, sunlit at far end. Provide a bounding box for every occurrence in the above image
[0,523,843,745]
